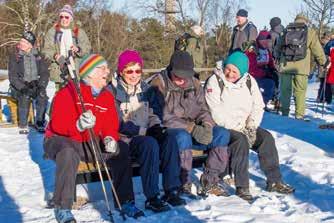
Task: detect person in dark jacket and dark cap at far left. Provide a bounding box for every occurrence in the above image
[8,32,49,134]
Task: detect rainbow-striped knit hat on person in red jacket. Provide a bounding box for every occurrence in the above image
[79,54,107,79]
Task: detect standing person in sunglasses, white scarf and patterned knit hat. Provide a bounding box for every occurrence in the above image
[42,5,91,90]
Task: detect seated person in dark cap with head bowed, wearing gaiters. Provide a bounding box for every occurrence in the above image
[147,51,229,197]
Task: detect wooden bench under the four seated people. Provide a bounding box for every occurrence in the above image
[74,150,207,198]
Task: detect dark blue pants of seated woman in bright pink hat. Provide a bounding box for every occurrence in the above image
[130,134,181,199]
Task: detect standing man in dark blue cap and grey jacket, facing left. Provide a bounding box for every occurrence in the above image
[230,9,257,53]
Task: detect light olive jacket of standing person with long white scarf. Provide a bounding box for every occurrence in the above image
[42,24,91,83]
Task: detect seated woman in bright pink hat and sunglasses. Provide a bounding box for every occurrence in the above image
[110,50,185,212]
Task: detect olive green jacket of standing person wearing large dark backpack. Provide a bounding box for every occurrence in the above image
[279,24,326,76]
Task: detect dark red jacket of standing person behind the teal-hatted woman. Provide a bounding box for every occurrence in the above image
[245,50,275,79]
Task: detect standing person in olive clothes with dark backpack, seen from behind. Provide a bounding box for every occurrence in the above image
[279,14,326,119]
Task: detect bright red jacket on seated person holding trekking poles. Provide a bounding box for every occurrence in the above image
[45,82,119,142]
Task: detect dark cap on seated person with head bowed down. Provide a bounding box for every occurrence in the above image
[170,51,195,78]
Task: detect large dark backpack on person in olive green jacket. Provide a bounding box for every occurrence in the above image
[283,23,308,61]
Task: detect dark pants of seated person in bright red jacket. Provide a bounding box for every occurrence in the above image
[44,136,134,209]
